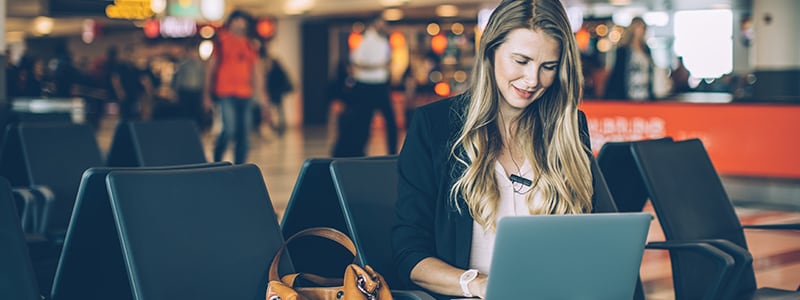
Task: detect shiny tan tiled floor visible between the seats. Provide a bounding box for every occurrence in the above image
[98,111,800,299]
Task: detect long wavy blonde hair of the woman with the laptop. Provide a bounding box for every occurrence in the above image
[450,0,592,230]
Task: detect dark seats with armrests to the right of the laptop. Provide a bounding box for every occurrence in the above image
[597,138,800,299]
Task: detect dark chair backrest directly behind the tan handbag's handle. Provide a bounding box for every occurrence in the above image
[281,158,353,277]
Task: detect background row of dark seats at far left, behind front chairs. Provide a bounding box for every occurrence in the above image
[0,120,206,290]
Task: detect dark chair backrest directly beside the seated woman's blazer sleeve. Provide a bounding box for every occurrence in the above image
[330,159,402,288]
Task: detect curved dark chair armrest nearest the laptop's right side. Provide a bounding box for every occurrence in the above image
[645,241,736,299]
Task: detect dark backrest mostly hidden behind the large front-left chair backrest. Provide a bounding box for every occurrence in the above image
[51,163,230,300]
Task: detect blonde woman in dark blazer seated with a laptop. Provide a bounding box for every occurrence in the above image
[392,0,593,298]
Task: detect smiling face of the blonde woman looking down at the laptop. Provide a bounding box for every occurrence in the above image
[494,28,561,114]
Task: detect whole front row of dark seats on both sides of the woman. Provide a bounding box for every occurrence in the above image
[0,122,798,299]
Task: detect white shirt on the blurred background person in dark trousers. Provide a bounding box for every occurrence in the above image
[350,28,392,83]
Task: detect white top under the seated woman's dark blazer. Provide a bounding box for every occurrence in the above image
[469,160,543,274]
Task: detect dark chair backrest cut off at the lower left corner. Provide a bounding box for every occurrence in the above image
[0,177,41,300]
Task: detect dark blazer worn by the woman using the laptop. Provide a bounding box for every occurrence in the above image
[392,95,595,296]
